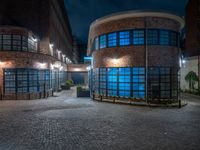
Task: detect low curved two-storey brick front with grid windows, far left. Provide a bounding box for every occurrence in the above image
[0,26,67,100]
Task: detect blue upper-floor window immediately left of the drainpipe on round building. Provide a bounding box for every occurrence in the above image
[133,30,144,45]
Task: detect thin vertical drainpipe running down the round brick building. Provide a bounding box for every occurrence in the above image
[145,17,148,103]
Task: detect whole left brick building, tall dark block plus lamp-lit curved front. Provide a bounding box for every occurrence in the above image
[0,0,77,99]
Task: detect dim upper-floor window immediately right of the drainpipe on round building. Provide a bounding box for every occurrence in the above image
[147,29,158,45]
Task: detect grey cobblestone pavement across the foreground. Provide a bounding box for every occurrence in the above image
[0,90,200,150]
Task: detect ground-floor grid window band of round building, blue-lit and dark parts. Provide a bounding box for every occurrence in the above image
[91,67,178,99]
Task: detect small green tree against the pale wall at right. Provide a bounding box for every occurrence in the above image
[185,71,198,92]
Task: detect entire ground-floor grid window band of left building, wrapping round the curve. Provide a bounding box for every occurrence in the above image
[4,68,67,94]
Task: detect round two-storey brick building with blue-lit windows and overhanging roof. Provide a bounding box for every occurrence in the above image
[88,11,184,103]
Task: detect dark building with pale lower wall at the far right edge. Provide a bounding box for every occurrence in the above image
[181,0,200,91]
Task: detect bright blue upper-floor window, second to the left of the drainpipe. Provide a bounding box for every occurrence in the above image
[119,31,130,46]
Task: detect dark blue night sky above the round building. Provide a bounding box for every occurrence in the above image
[65,0,188,43]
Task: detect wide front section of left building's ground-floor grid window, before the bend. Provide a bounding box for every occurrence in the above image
[4,68,51,94]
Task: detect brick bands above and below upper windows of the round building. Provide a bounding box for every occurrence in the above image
[89,16,184,68]
